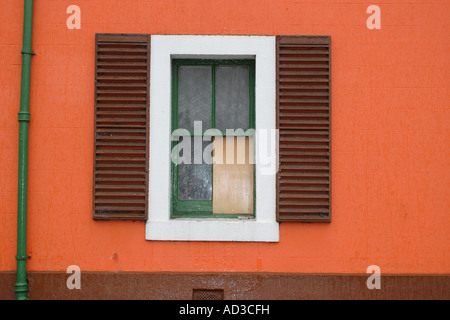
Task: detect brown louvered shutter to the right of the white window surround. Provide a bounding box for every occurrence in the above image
[277,36,331,222]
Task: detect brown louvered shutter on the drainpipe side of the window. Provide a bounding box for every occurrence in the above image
[93,34,150,220]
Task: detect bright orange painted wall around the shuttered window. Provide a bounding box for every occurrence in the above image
[0,0,450,273]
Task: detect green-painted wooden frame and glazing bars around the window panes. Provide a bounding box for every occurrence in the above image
[170,59,256,219]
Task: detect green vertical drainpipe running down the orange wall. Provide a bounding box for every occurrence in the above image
[15,0,34,300]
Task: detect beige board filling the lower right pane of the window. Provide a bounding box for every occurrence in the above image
[213,137,254,214]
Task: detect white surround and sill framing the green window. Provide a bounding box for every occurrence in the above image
[145,35,279,242]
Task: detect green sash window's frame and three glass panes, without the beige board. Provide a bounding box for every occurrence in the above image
[171,59,255,218]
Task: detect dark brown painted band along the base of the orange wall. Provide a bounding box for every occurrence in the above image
[0,272,450,300]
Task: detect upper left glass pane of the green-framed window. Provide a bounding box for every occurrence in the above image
[178,66,212,130]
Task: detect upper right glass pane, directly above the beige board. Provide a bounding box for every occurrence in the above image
[215,66,250,130]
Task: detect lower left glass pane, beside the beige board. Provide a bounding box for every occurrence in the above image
[178,137,212,200]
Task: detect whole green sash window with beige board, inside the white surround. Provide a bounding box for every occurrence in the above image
[171,59,255,218]
